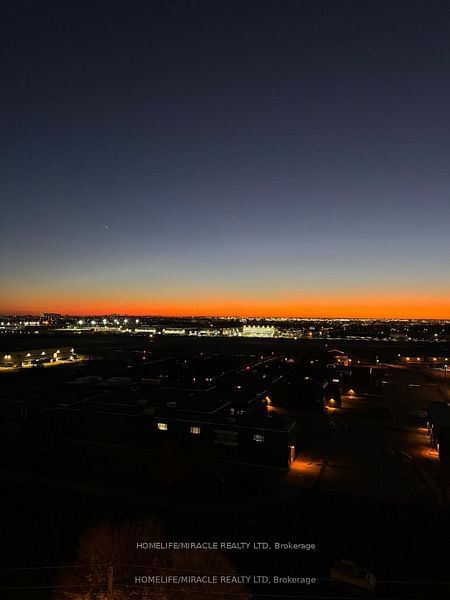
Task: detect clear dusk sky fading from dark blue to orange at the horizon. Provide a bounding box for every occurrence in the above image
[0,0,450,318]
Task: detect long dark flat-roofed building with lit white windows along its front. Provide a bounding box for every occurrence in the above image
[8,376,297,469]
